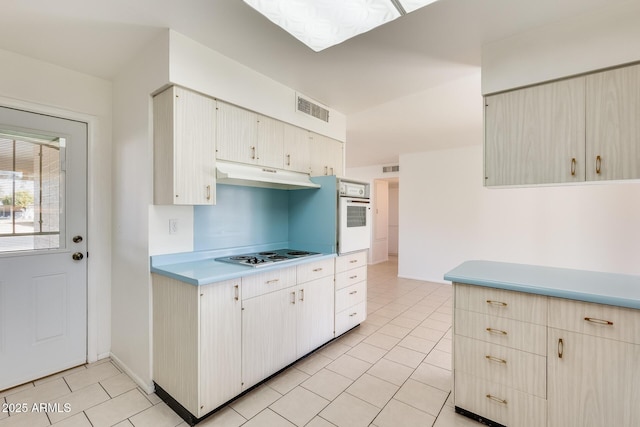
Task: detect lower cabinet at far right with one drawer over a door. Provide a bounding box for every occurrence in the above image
[548,298,640,427]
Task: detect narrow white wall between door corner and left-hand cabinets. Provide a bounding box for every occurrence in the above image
[111,32,170,392]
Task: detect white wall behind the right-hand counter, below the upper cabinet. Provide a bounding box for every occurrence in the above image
[399,145,640,282]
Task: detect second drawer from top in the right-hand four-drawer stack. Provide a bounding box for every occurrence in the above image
[454,309,547,356]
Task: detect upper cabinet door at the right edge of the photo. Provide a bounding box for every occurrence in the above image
[586,65,640,180]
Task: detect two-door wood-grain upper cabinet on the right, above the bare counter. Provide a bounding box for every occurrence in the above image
[484,65,640,186]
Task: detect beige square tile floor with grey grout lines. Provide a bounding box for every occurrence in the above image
[0,259,480,427]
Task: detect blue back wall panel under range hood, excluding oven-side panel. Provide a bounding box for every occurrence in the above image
[193,184,289,251]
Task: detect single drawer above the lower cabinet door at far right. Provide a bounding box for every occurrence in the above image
[549,298,640,344]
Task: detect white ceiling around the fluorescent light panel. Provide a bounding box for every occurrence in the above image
[0,0,625,167]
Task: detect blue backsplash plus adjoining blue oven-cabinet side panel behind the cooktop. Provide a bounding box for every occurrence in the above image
[193,176,337,253]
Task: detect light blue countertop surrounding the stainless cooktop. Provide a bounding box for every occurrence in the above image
[151,251,336,286]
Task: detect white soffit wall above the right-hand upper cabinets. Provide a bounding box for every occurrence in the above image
[482,1,640,94]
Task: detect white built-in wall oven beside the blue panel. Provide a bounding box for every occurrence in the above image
[338,179,371,254]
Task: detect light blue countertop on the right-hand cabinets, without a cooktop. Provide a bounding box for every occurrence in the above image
[444,261,640,309]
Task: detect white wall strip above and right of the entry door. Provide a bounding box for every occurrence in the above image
[0,46,112,361]
